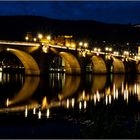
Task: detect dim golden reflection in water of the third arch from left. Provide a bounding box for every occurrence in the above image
[91,75,107,93]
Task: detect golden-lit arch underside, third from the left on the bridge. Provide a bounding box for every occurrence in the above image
[91,56,107,74]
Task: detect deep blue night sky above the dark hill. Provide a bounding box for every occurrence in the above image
[0,1,140,24]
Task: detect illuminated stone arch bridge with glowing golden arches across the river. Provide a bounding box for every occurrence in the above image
[0,40,140,75]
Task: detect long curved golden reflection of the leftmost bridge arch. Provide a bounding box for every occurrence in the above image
[9,76,40,105]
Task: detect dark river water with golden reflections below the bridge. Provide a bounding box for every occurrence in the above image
[0,72,140,138]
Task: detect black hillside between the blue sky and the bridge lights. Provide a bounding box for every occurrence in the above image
[0,16,140,42]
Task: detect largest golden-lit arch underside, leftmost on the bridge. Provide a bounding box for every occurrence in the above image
[7,48,40,75]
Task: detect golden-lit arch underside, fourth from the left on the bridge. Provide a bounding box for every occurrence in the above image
[111,56,125,73]
